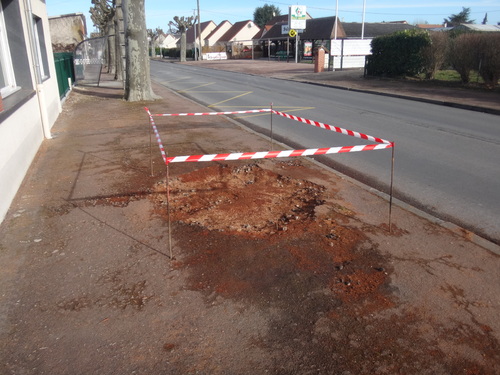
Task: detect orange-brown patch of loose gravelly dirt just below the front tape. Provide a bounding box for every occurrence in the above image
[160,164,325,234]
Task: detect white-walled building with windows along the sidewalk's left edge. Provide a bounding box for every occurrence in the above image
[0,0,61,221]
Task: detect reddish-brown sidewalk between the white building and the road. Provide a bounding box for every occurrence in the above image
[0,72,500,375]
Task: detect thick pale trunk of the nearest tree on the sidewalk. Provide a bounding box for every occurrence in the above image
[122,0,159,102]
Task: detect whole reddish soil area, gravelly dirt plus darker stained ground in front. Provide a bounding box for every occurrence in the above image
[153,164,392,313]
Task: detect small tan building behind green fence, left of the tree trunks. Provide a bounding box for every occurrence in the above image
[49,13,87,52]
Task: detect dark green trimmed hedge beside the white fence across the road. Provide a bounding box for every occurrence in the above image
[367,29,431,76]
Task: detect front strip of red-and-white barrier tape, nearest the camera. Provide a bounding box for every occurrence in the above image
[167,143,393,164]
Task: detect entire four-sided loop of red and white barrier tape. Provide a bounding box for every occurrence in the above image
[144,108,394,165]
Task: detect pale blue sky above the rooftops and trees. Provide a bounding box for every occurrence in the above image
[46,0,500,32]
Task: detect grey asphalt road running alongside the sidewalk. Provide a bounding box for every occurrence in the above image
[151,61,500,243]
